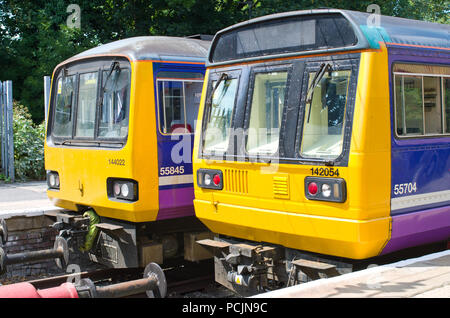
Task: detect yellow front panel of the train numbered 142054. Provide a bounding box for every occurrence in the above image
[194,48,391,259]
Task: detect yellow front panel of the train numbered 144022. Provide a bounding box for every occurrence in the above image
[45,62,158,222]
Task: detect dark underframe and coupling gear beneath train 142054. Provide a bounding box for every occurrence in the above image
[197,234,447,297]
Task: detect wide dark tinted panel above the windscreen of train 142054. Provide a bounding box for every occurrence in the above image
[211,14,357,62]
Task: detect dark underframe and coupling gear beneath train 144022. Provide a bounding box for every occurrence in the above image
[46,210,213,268]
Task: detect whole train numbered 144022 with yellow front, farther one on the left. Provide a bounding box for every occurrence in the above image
[45,37,210,267]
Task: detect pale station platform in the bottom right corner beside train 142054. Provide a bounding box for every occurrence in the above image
[254,250,450,298]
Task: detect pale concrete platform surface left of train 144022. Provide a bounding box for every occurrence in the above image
[0,181,59,218]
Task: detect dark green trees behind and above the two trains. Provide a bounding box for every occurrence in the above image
[0,0,450,123]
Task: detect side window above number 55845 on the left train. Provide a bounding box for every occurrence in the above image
[157,72,203,134]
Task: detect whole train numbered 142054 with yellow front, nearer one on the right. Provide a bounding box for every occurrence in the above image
[194,9,450,291]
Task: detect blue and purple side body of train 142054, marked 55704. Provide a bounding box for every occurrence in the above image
[382,44,450,254]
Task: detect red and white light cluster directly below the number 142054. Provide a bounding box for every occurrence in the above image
[305,177,347,202]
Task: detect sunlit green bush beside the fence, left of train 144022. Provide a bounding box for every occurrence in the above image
[13,102,45,180]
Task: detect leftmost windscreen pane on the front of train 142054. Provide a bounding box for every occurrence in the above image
[203,73,238,153]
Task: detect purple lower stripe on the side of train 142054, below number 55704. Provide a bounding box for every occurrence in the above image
[381,206,450,255]
